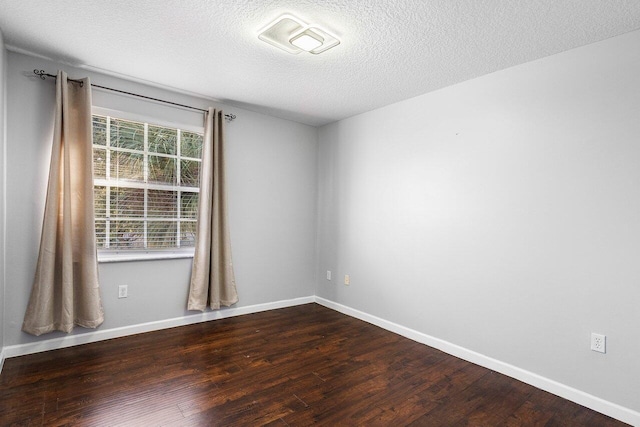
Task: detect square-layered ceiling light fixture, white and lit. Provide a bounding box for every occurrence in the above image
[258,15,340,55]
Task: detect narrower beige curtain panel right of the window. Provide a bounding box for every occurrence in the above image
[187,108,238,311]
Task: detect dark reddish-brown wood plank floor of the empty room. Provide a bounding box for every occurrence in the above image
[0,304,624,426]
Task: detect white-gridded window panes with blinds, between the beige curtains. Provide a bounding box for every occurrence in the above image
[93,115,202,252]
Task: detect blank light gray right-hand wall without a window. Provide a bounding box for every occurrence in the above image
[316,31,640,419]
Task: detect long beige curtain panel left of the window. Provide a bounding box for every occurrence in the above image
[22,71,104,335]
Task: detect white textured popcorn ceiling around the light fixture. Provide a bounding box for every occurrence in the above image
[0,0,640,125]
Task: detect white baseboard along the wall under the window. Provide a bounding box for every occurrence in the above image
[0,296,315,362]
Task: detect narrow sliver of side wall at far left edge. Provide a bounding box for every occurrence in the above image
[0,32,7,363]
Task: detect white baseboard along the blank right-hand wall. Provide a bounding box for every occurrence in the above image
[315,296,640,426]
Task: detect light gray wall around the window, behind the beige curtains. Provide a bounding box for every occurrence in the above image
[4,52,317,346]
